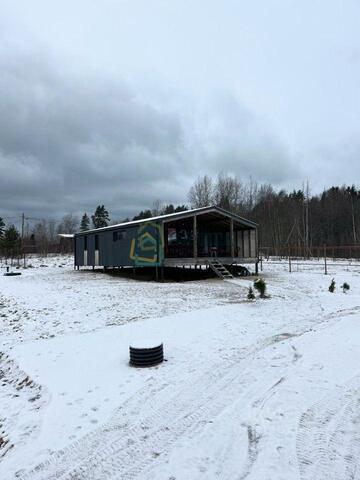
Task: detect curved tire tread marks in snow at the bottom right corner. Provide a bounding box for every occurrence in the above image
[296,375,360,480]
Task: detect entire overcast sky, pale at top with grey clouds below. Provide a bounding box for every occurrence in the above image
[0,0,360,219]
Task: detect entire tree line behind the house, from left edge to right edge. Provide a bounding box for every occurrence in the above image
[0,174,360,256]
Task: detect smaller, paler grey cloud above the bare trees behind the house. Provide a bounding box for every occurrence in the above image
[184,94,300,185]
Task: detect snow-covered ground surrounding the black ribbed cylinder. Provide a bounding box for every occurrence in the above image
[0,257,360,480]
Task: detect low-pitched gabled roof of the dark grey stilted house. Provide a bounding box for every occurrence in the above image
[75,206,258,236]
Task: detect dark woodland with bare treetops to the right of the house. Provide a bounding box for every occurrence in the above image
[188,174,360,248]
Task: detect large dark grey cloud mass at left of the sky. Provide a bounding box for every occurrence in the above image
[0,51,186,214]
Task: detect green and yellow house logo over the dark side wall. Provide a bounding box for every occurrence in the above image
[130,222,164,267]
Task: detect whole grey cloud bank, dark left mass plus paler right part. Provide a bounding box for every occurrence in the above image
[0,47,296,218]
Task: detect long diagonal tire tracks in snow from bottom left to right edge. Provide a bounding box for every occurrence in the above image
[20,309,355,480]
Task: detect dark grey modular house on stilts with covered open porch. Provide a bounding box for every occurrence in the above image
[74,207,258,278]
